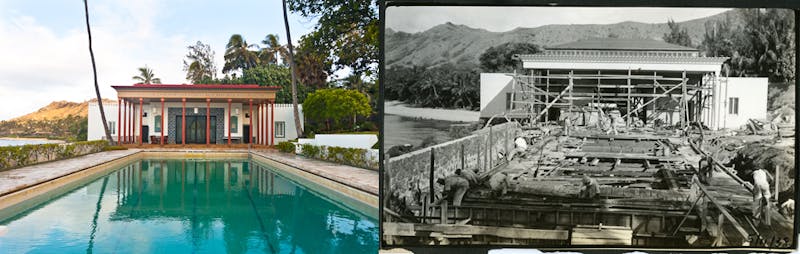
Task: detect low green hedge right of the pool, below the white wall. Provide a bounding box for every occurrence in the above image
[301,144,378,170]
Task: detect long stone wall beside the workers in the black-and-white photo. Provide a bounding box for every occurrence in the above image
[384,122,520,199]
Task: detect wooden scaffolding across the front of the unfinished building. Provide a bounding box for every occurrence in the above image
[506,70,716,132]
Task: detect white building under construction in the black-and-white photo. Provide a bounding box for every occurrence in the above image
[480,38,767,130]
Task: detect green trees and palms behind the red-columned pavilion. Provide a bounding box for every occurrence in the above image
[127,0,380,135]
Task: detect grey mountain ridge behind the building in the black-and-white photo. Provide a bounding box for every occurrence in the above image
[385,11,741,68]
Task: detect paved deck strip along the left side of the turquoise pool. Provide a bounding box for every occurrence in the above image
[0,149,141,196]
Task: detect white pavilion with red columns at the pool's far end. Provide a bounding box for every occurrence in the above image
[88,84,303,145]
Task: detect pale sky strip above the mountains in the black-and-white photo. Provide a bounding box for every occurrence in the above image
[386,6,729,33]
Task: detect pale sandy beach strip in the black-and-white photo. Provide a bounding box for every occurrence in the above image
[383,101,480,122]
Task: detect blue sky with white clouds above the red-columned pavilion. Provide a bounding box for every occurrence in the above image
[0,0,316,120]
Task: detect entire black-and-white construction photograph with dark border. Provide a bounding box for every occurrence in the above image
[380,6,796,249]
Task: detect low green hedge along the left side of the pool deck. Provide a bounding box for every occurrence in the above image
[0,140,108,170]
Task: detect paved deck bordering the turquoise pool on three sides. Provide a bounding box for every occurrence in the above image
[0,148,379,196]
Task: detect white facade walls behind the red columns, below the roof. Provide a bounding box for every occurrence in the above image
[87,102,303,144]
